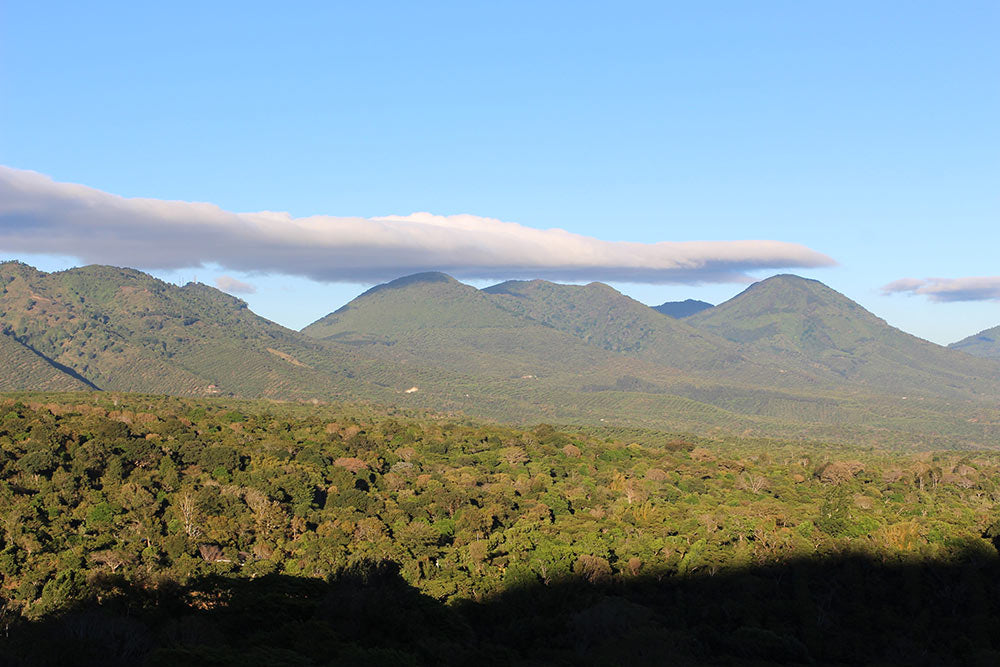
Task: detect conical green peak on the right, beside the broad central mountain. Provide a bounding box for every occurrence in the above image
[685,275,1000,396]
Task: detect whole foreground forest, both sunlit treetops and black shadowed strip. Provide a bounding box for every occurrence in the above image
[0,393,1000,664]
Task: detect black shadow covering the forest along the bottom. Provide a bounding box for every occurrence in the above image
[0,556,1000,667]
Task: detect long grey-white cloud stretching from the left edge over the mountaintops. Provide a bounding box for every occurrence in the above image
[0,166,835,284]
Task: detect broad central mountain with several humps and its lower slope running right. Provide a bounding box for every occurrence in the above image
[303,273,997,446]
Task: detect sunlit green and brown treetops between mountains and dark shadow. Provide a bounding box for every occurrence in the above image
[0,394,1000,664]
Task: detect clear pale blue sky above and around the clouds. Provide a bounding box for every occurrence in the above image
[0,0,1000,343]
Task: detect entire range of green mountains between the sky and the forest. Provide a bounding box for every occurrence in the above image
[0,262,1000,444]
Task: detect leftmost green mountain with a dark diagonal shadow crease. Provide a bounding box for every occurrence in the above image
[0,262,398,398]
